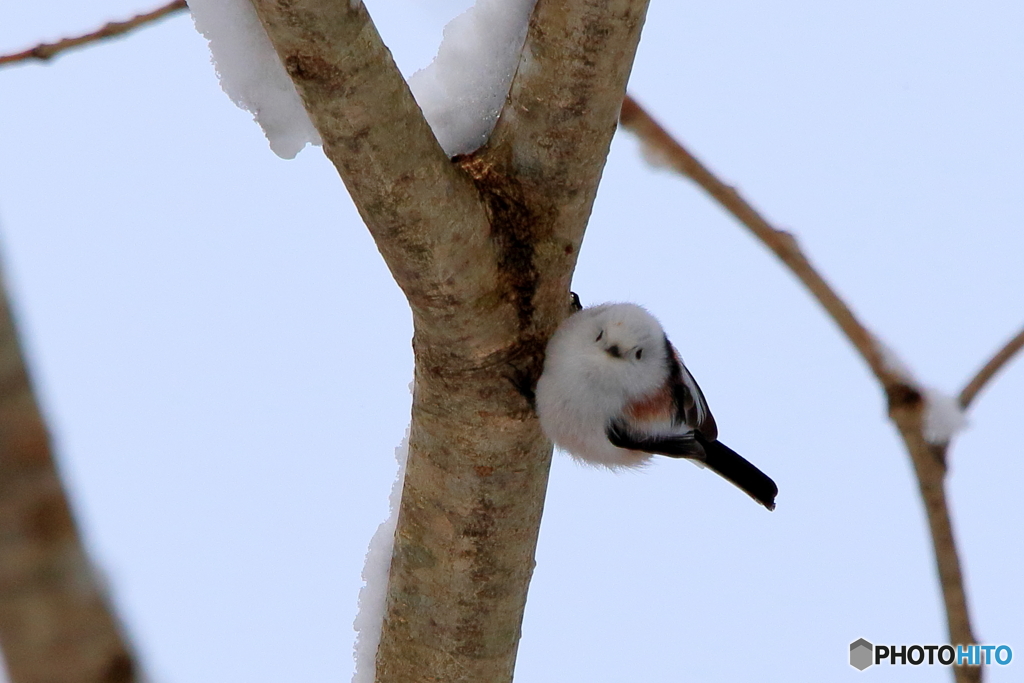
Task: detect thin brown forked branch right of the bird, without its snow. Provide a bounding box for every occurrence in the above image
[621,96,1024,683]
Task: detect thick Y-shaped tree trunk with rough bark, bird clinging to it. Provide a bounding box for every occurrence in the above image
[252,0,647,683]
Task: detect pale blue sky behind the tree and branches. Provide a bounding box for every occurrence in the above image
[0,0,1024,683]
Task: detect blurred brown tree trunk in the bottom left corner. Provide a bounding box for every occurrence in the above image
[0,266,136,683]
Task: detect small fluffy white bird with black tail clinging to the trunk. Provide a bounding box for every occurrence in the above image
[537,303,778,510]
